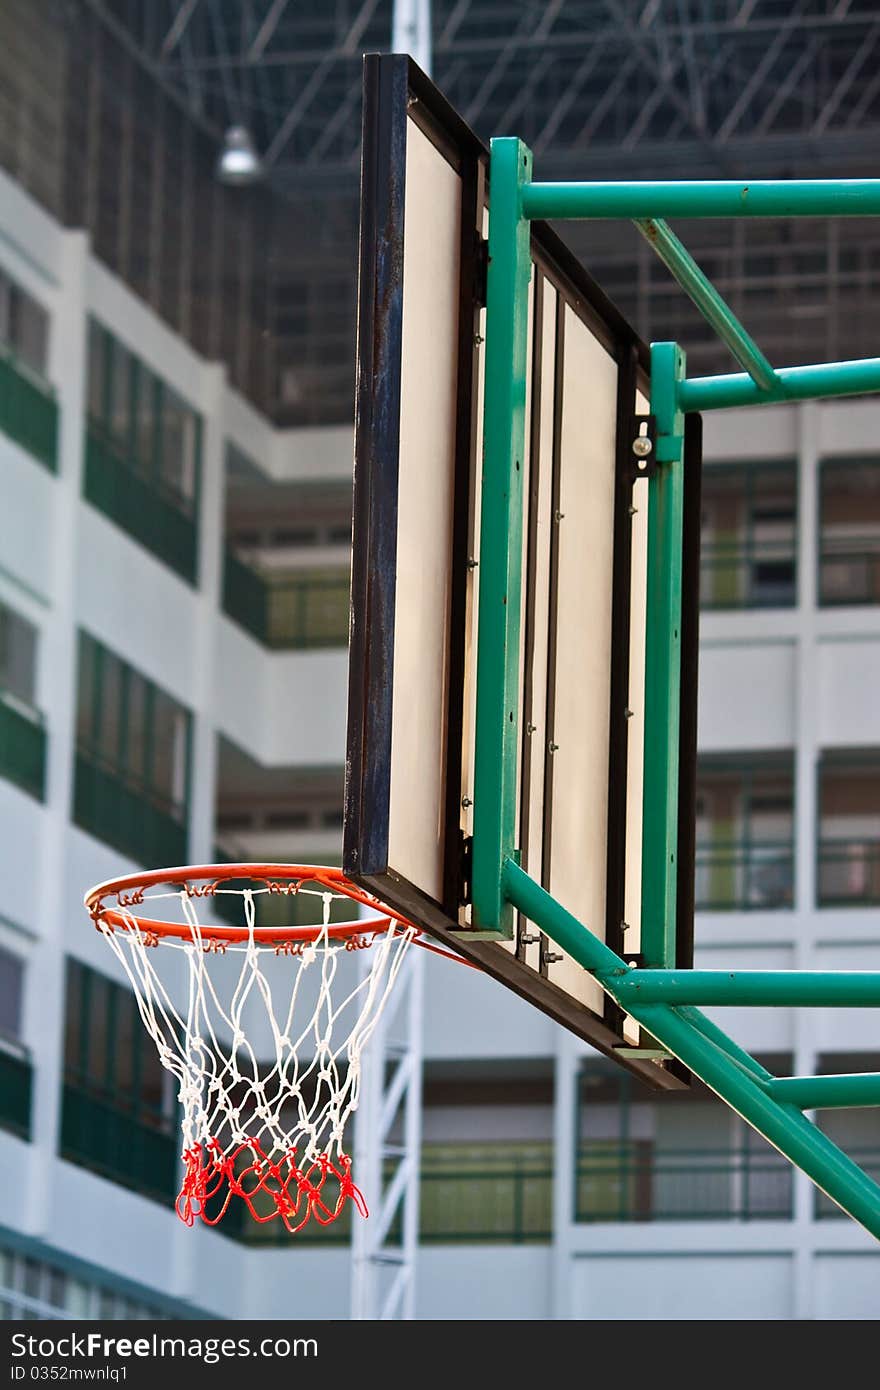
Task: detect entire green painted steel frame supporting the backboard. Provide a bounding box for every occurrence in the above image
[473,146,880,1240]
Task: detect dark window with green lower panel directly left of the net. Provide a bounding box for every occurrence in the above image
[61,958,178,1198]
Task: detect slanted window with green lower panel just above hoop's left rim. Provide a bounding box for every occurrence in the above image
[74,632,192,865]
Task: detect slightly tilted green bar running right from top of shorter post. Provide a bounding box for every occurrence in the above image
[678,357,880,411]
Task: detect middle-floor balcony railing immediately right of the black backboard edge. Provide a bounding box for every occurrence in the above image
[695,840,794,912]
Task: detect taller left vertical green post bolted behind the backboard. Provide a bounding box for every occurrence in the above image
[471,139,531,937]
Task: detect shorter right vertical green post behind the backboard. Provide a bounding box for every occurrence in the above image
[641,343,684,966]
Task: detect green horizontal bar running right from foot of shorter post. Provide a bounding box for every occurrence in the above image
[614,970,880,1009]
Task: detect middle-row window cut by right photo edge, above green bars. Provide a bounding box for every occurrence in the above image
[817,748,880,908]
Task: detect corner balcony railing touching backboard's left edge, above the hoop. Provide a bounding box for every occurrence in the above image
[222,550,349,651]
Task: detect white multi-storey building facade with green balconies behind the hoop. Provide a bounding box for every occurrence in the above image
[0,168,880,1319]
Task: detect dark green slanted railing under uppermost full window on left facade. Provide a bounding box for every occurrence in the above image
[83,421,197,584]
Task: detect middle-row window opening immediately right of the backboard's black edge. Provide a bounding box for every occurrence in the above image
[696,752,794,912]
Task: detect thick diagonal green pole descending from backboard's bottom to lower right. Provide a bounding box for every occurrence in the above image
[502,859,880,1240]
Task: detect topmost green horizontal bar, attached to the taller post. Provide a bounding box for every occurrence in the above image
[523,178,880,221]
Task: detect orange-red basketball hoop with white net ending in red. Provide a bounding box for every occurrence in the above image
[85,863,417,1233]
